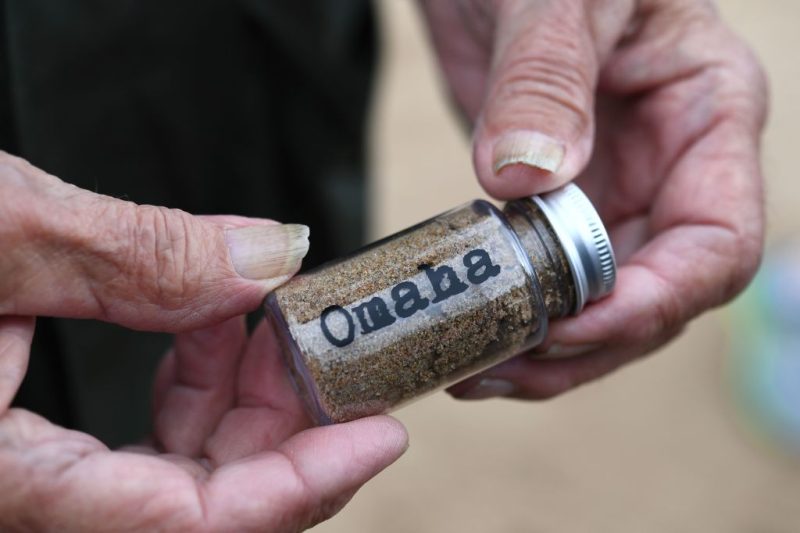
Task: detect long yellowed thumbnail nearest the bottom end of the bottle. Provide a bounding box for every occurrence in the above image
[225,224,309,280]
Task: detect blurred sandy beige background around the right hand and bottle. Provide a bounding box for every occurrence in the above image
[314,0,800,533]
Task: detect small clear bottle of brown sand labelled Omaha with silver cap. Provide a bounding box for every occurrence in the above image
[266,184,616,424]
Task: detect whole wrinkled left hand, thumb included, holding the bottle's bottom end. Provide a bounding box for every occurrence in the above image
[0,153,406,531]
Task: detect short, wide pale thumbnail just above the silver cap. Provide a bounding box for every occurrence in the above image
[494,131,566,174]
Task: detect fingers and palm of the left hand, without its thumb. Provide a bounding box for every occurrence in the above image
[0,317,406,532]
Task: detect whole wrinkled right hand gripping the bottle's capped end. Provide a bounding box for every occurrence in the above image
[422,0,767,398]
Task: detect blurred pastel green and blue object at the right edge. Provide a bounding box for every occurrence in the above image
[729,242,800,454]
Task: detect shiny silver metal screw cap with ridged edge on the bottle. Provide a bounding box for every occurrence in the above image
[532,183,617,314]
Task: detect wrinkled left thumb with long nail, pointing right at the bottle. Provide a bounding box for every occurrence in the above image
[0,153,308,331]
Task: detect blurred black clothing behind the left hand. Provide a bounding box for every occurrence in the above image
[0,0,376,445]
